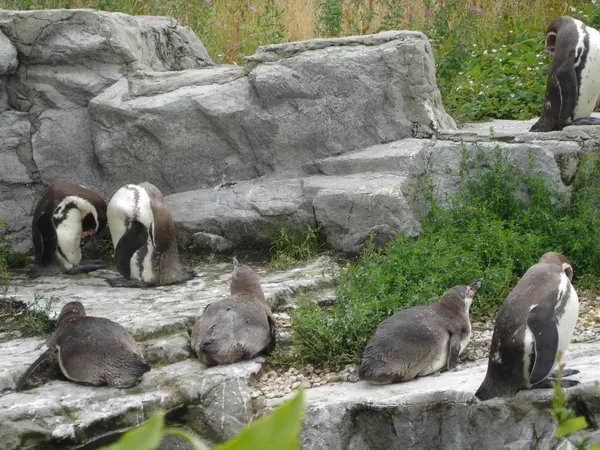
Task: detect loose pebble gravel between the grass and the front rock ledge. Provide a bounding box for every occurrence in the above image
[252,292,600,399]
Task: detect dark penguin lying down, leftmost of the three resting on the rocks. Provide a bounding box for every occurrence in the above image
[16,302,150,391]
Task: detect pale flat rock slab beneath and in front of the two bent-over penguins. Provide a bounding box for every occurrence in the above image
[0,256,337,389]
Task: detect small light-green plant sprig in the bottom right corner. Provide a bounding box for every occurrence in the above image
[550,353,600,450]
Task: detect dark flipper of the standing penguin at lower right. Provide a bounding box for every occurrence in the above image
[527,301,558,384]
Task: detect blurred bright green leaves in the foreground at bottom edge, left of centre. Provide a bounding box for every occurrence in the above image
[103,390,304,450]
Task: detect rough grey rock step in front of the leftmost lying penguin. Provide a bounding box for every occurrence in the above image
[0,358,263,450]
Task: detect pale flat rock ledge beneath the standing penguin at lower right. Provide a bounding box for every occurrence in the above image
[267,342,600,450]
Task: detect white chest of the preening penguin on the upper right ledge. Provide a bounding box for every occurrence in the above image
[573,21,600,120]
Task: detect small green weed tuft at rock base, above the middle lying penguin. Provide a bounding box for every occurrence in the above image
[268,225,321,270]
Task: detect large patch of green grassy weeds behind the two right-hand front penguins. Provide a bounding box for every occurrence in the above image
[292,149,600,367]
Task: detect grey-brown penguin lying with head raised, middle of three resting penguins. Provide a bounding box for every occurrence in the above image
[190,258,276,366]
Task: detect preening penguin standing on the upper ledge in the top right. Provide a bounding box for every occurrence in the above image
[529,16,600,132]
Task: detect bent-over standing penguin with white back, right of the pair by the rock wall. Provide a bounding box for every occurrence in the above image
[105,182,195,288]
